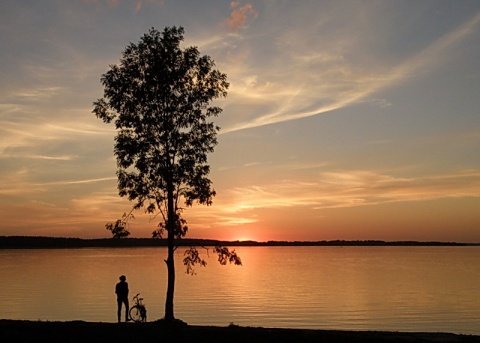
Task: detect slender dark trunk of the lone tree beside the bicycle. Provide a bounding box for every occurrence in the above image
[165,183,176,321]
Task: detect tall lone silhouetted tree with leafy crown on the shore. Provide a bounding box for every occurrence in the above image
[93,27,241,320]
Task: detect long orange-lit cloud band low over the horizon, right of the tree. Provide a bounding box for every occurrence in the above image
[177,170,480,234]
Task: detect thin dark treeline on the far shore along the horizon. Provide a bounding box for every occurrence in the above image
[0,236,480,249]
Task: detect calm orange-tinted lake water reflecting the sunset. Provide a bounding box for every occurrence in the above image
[0,247,480,335]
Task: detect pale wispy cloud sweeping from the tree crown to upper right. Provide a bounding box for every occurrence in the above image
[221,13,480,133]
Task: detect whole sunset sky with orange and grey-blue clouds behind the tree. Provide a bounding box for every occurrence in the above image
[0,0,480,242]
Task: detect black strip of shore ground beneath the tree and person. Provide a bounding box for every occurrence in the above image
[0,320,480,343]
